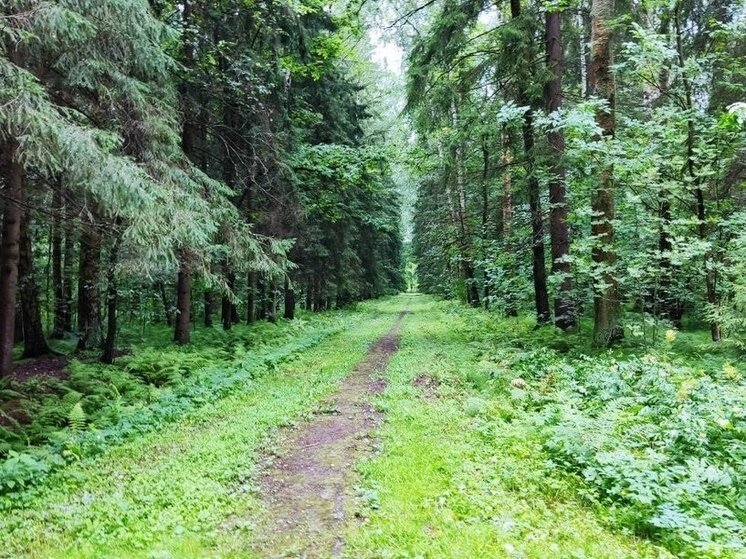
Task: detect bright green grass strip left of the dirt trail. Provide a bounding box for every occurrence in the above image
[0,301,399,559]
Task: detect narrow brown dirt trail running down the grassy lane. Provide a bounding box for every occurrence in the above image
[254,312,407,559]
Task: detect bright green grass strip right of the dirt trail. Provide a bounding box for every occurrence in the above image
[346,297,692,559]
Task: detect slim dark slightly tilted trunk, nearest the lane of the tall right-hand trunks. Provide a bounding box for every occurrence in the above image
[510,0,552,326]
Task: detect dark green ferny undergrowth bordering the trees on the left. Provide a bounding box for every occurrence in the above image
[0,311,354,508]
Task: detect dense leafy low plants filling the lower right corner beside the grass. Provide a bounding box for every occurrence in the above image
[493,349,746,557]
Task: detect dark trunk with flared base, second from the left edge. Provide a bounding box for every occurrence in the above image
[18,211,52,359]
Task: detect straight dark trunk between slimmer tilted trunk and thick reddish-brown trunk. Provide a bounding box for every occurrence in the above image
[544,6,576,330]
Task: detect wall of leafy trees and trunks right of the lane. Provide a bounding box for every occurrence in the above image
[400,0,746,346]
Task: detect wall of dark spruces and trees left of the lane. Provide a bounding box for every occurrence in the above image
[0,0,402,374]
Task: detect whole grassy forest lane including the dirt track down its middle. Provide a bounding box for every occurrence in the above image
[0,295,743,559]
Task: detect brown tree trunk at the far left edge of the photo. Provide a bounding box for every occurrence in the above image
[0,140,24,377]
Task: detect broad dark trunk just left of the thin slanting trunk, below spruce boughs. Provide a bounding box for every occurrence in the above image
[77,215,102,351]
